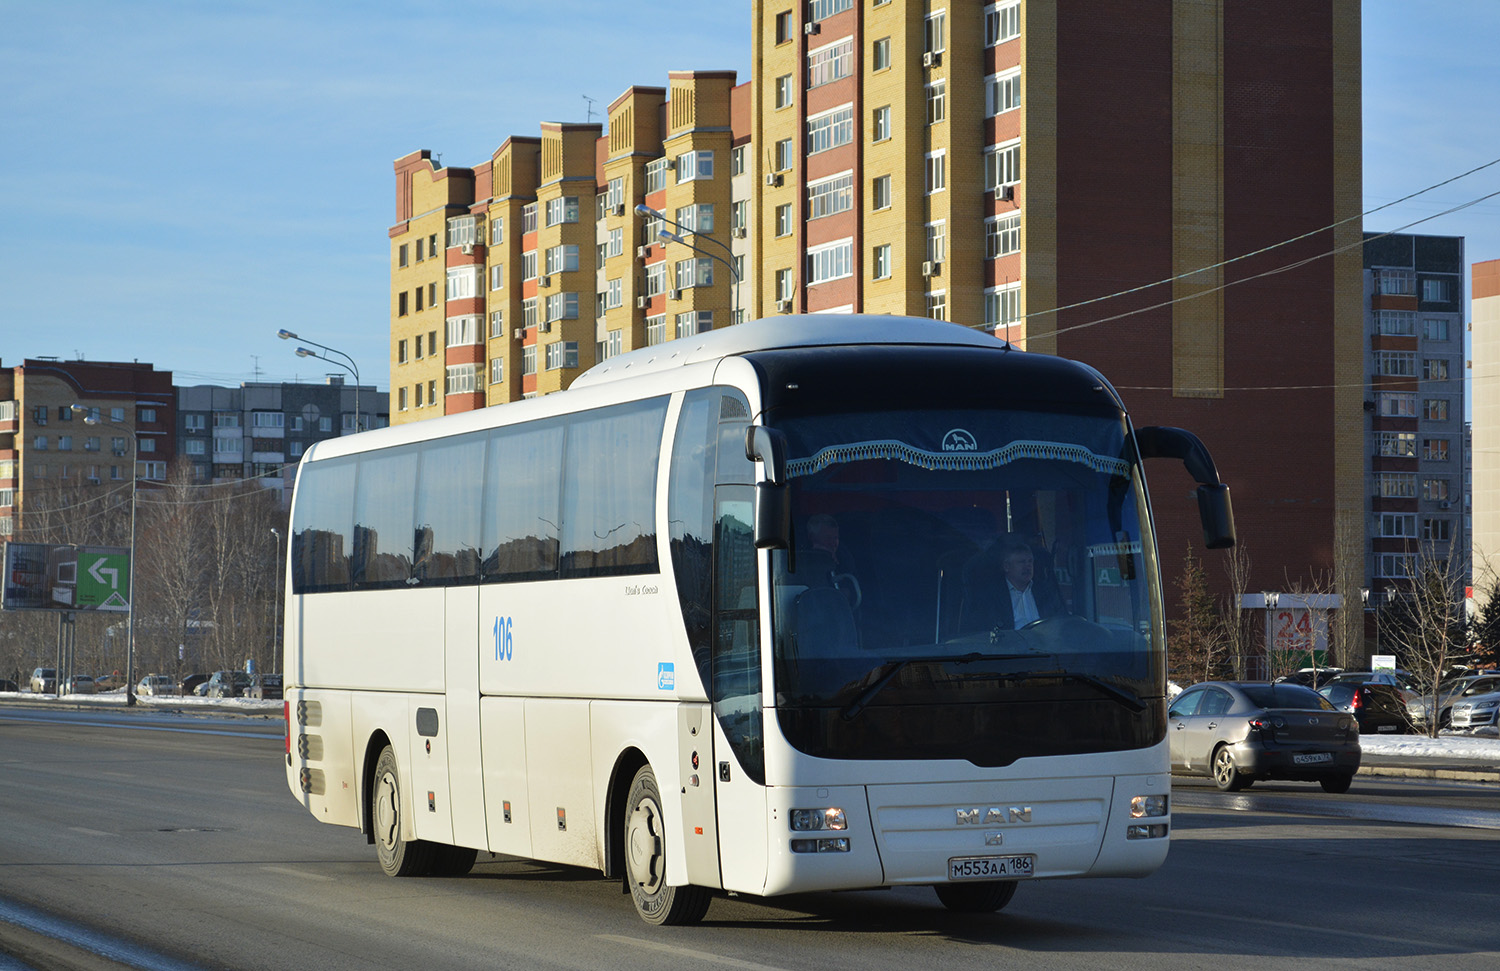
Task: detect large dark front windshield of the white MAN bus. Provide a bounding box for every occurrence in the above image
[771,408,1166,765]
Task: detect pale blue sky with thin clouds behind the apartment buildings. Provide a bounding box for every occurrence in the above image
[0,0,1500,389]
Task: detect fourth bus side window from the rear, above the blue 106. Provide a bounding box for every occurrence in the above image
[483,422,564,582]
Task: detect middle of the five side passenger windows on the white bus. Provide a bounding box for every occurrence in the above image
[413,435,486,585]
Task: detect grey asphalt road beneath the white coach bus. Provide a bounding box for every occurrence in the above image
[0,708,1500,971]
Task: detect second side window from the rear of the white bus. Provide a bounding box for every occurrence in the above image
[351,446,417,590]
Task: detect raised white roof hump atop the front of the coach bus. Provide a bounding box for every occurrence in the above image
[570,314,1010,387]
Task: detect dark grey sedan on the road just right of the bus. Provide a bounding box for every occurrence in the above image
[1167,681,1361,792]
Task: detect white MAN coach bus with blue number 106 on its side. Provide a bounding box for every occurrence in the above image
[285,315,1233,923]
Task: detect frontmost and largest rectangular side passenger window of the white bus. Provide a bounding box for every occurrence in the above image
[560,398,666,576]
